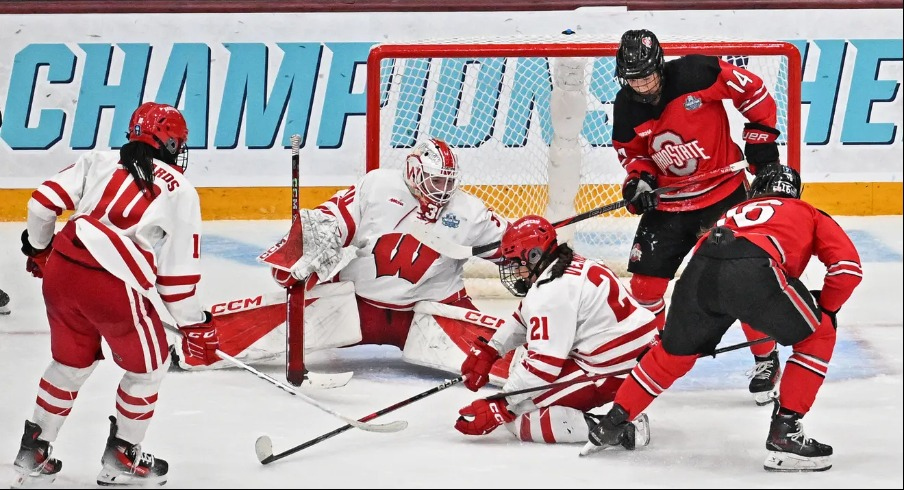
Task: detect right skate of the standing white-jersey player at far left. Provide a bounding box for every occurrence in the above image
[97,416,169,487]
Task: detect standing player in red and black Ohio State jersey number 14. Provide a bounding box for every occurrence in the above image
[612,29,780,405]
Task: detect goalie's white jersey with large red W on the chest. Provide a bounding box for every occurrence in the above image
[317,169,508,310]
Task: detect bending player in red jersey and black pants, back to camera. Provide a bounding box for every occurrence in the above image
[590,166,862,471]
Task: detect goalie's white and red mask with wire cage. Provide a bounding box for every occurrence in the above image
[405,138,459,220]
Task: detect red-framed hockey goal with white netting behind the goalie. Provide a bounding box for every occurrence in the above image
[366,35,801,294]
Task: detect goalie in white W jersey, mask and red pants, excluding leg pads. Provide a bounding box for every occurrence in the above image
[274,139,508,349]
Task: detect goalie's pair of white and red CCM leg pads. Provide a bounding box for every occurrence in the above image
[172,281,521,386]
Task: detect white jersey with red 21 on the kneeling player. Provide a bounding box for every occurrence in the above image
[490,254,656,406]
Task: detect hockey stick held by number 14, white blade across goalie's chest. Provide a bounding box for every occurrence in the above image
[409,160,750,259]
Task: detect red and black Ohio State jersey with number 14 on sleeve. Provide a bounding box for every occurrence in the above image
[612,55,776,211]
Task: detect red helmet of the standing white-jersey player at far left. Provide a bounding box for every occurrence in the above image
[126,102,188,172]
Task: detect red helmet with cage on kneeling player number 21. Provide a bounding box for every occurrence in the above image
[499,215,558,297]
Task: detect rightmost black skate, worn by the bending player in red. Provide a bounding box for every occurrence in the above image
[763,403,832,472]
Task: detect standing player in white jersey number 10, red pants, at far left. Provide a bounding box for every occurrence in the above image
[13,102,218,486]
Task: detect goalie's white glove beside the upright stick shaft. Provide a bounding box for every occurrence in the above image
[292,209,342,280]
